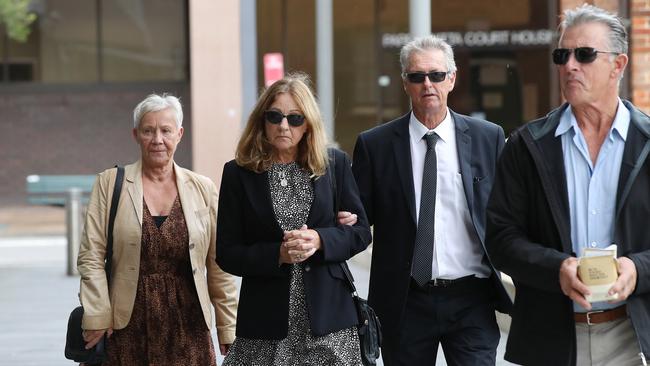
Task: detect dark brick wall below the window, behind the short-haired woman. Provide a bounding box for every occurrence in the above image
[0,83,192,204]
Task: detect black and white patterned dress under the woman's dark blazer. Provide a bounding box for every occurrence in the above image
[223,162,362,366]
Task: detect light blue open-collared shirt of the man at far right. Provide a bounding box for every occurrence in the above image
[555,99,630,312]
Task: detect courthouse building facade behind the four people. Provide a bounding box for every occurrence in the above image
[0,0,650,204]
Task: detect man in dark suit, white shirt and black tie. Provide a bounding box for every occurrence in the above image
[353,36,511,366]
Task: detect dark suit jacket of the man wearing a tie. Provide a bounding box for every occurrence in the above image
[352,112,512,350]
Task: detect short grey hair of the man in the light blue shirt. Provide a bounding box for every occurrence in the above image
[559,4,628,54]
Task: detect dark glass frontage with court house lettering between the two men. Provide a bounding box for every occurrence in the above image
[431,0,552,134]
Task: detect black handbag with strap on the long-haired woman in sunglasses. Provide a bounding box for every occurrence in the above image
[328,150,381,366]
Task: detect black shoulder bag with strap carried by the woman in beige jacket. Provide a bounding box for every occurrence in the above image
[65,166,124,366]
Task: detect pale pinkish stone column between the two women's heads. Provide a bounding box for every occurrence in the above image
[189,0,242,187]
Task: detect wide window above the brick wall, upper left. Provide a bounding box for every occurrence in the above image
[0,0,188,83]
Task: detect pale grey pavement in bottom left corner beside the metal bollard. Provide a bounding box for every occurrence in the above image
[0,237,79,366]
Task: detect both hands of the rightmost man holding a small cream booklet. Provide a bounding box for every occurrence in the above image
[560,257,637,311]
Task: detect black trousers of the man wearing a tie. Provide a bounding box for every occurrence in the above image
[382,277,501,366]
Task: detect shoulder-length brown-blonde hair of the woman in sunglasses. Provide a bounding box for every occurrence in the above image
[235,73,328,176]
